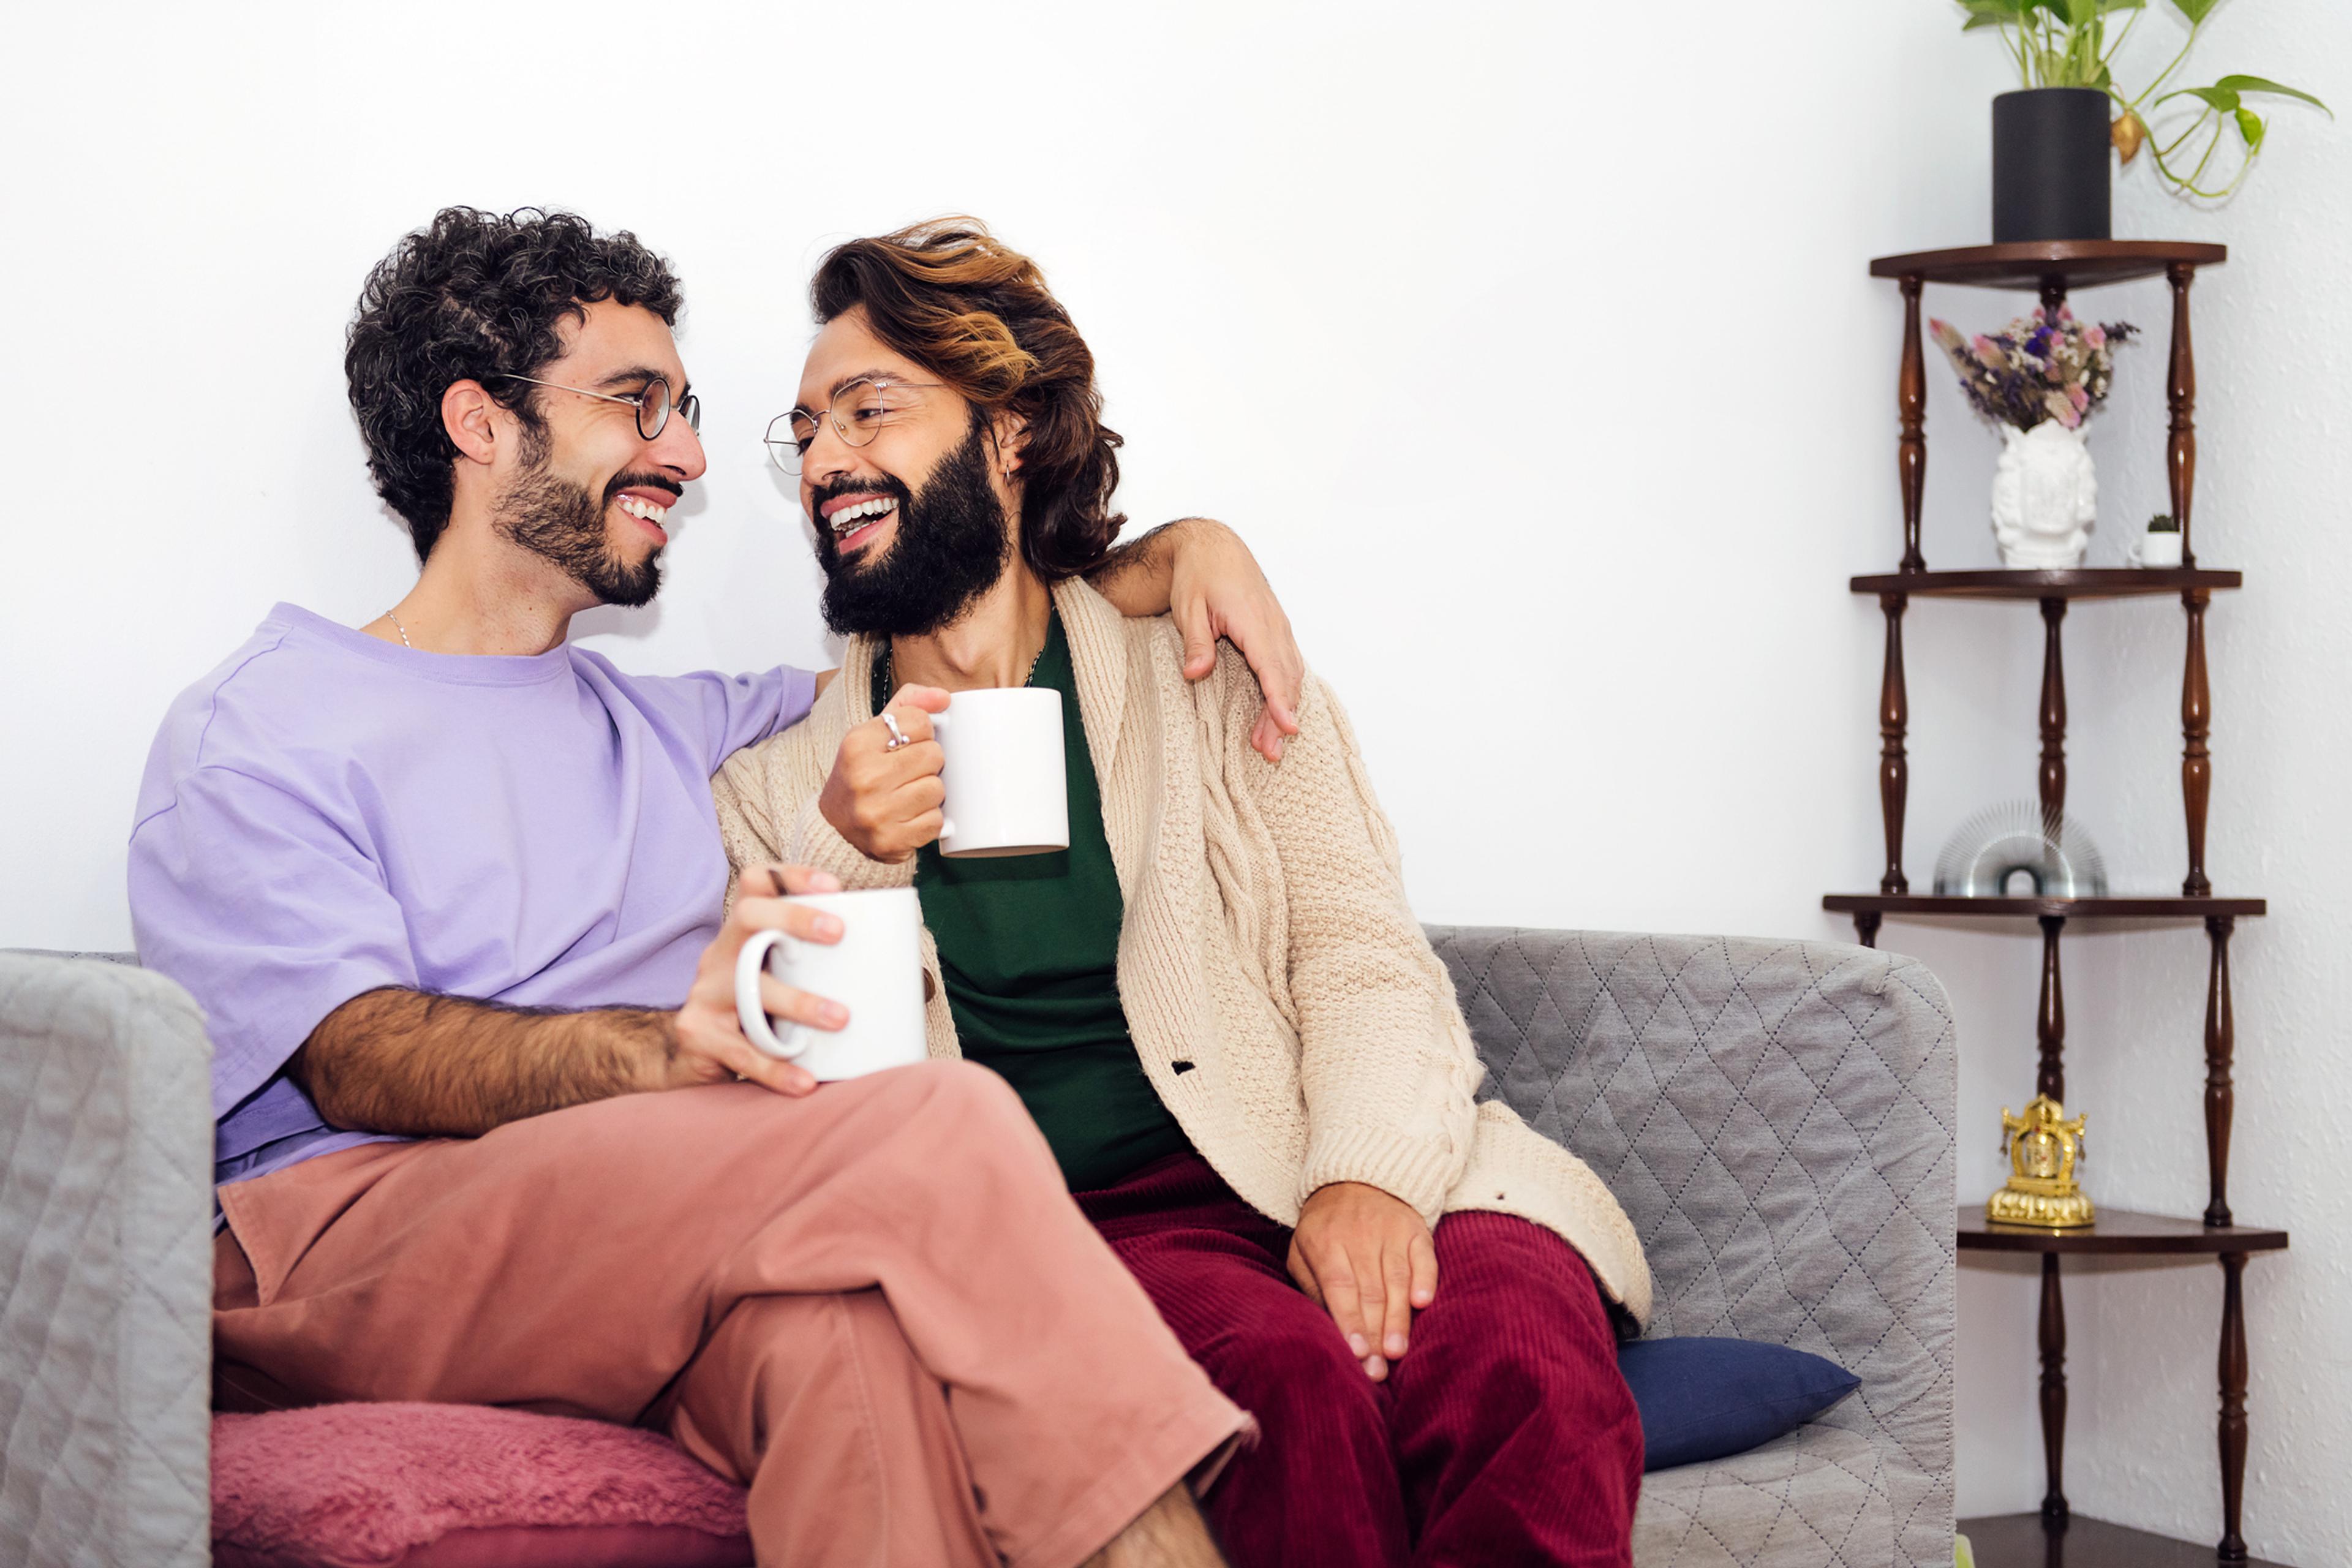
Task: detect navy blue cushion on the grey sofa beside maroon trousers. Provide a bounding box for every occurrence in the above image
[1618,1338,1863,1469]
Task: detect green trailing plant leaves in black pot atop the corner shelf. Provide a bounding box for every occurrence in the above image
[1959,0,2335,200]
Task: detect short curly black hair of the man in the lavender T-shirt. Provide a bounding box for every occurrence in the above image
[344,207,682,559]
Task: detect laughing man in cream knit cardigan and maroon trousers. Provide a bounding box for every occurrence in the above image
[715,219,1649,1568]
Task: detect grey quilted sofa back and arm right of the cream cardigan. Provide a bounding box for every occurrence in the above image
[1430,929,1957,1563]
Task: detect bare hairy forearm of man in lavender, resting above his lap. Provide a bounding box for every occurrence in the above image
[287,990,677,1138]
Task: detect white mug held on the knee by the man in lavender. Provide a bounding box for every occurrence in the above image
[736,889,929,1084]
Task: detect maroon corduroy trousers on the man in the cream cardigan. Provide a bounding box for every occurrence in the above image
[1077,1154,1642,1568]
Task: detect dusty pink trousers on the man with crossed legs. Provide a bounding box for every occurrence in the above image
[214,1063,1249,1568]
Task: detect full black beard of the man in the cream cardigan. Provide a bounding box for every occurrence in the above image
[814,418,1011,637]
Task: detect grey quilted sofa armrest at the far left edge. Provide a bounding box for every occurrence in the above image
[0,952,212,1568]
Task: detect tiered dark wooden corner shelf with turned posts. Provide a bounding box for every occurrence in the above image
[1853,239,2286,1568]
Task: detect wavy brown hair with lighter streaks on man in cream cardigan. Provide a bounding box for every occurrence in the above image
[809,216,1126,583]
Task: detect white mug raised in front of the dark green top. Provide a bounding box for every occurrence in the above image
[932,687,1070,858]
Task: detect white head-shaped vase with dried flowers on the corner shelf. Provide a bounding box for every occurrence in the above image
[1931,306,2138,571]
